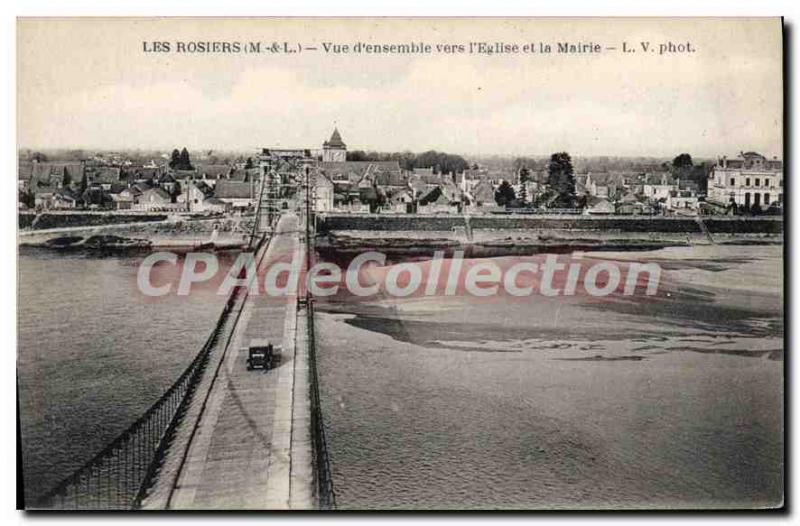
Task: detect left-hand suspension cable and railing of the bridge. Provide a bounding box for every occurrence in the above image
[30,239,263,510]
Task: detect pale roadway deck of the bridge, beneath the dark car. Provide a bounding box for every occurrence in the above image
[145,215,312,509]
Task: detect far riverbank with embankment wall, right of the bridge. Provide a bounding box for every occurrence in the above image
[316,214,783,257]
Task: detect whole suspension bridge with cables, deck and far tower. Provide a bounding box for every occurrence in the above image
[27,150,335,510]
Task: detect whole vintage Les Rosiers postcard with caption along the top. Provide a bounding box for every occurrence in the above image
[17,18,785,510]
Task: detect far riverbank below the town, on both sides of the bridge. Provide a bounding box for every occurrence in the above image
[17,214,783,257]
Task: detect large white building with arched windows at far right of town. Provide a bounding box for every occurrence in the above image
[708,152,783,209]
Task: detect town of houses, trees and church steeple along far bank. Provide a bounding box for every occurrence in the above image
[18,129,783,221]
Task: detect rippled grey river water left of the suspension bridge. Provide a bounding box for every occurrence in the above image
[17,248,236,506]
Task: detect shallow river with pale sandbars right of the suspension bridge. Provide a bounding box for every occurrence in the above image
[316,246,783,509]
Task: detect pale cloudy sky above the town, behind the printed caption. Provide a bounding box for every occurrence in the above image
[17,18,783,158]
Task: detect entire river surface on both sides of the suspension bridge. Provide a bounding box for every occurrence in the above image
[18,246,784,509]
